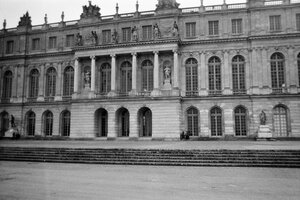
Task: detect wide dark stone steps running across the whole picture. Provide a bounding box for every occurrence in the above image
[0,147,300,167]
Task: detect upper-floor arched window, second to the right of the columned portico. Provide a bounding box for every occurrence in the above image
[208,56,222,95]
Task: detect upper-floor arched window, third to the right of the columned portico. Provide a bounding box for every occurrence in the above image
[232,56,246,94]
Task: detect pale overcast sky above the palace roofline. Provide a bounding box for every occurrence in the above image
[0,0,246,29]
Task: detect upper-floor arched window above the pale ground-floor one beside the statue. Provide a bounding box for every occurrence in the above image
[271,53,285,93]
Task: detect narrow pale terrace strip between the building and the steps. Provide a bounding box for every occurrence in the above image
[0,140,300,150]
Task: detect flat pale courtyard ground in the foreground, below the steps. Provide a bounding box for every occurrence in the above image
[0,161,300,200]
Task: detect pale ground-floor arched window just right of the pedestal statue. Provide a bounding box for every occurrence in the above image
[273,105,288,137]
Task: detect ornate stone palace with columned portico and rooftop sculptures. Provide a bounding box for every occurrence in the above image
[0,0,300,139]
